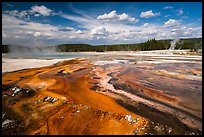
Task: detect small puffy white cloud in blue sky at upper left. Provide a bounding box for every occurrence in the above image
[31,5,52,16]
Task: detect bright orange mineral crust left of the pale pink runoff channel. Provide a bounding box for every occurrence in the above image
[2,59,148,134]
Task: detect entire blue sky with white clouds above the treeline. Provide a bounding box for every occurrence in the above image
[2,2,202,47]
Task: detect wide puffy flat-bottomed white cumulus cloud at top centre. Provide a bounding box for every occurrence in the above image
[97,10,138,22]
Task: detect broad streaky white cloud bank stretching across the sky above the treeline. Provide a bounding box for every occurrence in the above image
[2,6,202,46]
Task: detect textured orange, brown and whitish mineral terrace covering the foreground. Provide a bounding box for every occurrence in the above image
[2,52,202,135]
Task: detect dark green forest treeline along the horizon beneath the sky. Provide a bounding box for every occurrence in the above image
[2,38,202,53]
